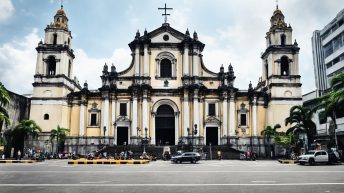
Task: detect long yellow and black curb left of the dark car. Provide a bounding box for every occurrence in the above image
[68,159,150,164]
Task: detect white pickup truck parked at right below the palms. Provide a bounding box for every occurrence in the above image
[299,150,329,165]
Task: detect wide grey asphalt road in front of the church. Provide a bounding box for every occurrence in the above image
[0,160,344,193]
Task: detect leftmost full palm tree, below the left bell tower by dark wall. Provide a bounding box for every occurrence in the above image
[12,120,42,152]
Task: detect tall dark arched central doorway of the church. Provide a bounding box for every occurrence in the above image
[155,105,175,145]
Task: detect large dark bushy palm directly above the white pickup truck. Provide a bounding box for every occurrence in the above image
[285,105,316,150]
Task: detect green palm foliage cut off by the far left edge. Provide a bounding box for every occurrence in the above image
[0,82,10,140]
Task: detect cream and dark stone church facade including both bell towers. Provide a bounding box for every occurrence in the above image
[30,7,302,154]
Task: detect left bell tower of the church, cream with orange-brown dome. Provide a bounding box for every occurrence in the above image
[30,5,81,132]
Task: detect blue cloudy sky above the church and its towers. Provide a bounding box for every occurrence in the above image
[0,0,343,94]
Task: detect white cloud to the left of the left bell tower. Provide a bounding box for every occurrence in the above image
[0,29,40,94]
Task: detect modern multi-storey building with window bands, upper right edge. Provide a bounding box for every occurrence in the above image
[312,9,344,96]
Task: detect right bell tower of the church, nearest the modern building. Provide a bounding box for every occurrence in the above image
[261,5,302,126]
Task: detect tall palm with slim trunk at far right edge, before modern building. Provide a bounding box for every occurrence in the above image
[316,72,344,148]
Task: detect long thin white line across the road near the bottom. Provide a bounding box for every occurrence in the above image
[0,183,344,187]
